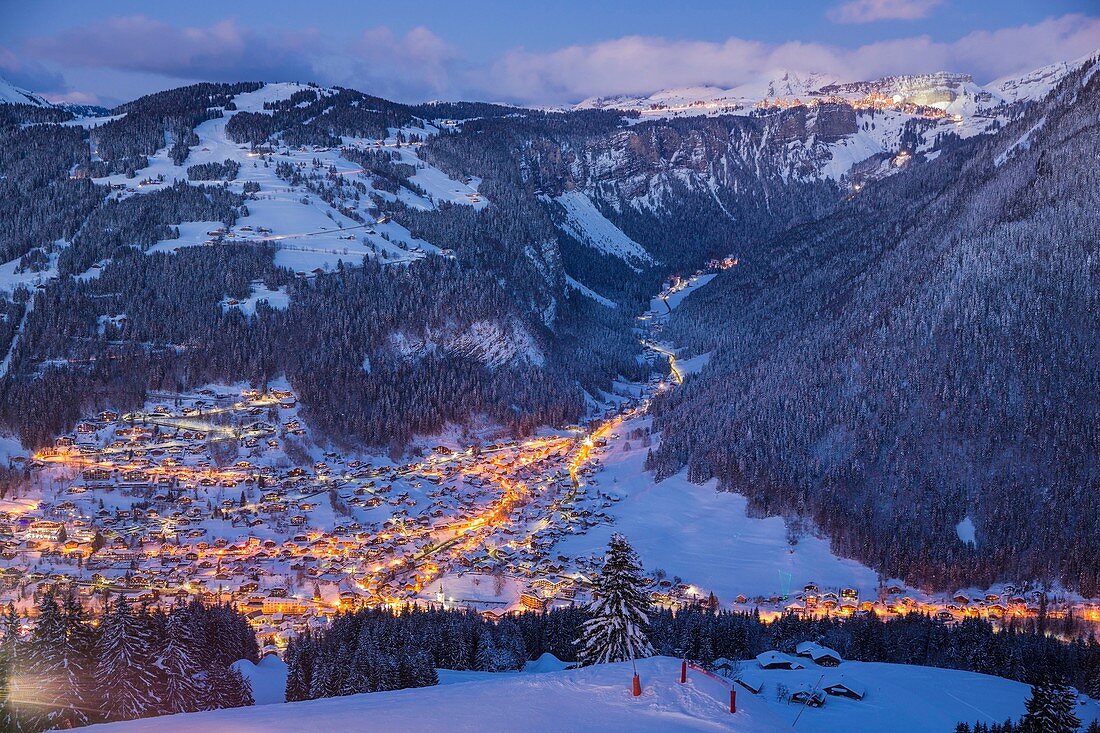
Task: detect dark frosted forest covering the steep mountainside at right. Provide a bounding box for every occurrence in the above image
[648,64,1100,595]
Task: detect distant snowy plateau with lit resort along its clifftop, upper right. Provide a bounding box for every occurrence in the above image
[574,57,1088,189]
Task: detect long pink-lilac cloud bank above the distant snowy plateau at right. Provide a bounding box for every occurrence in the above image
[483,14,1100,103]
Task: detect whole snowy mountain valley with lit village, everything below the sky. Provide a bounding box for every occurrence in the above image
[0,28,1100,733]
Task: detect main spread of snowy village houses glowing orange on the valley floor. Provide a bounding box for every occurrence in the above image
[0,387,642,647]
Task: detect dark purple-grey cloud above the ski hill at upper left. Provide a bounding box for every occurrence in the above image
[26,15,319,81]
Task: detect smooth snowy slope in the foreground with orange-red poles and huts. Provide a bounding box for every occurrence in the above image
[81,657,1100,733]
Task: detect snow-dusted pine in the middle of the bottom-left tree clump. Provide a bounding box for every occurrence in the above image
[96,598,157,720]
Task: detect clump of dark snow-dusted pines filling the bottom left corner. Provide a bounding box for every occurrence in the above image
[0,592,259,733]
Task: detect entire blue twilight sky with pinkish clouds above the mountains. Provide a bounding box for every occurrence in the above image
[0,0,1100,105]
